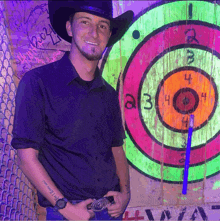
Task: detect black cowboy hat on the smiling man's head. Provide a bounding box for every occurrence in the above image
[48,0,134,47]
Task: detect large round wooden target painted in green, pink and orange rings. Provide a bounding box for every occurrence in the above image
[101,1,220,183]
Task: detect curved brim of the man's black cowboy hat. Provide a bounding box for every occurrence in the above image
[49,1,134,47]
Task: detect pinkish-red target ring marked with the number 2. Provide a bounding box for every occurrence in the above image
[123,24,220,166]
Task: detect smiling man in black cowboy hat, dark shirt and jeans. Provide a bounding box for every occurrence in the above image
[12,0,133,220]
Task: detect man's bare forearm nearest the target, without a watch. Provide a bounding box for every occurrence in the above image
[112,147,130,195]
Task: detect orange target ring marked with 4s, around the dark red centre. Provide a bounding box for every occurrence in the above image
[158,70,216,130]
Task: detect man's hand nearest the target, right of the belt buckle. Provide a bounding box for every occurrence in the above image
[105,191,130,218]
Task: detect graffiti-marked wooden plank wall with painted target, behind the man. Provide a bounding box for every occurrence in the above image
[5,0,220,220]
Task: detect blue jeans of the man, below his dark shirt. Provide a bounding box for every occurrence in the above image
[46,200,123,221]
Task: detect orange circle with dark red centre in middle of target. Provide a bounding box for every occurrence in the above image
[156,67,217,133]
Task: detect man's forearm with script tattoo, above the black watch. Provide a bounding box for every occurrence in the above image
[19,158,64,206]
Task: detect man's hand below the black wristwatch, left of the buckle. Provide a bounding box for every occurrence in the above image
[59,199,95,220]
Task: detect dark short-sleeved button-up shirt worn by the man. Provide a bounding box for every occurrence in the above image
[12,52,125,207]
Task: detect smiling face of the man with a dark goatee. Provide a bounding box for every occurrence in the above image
[66,12,111,61]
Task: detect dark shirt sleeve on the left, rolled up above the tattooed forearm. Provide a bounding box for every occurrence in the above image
[11,72,45,150]
